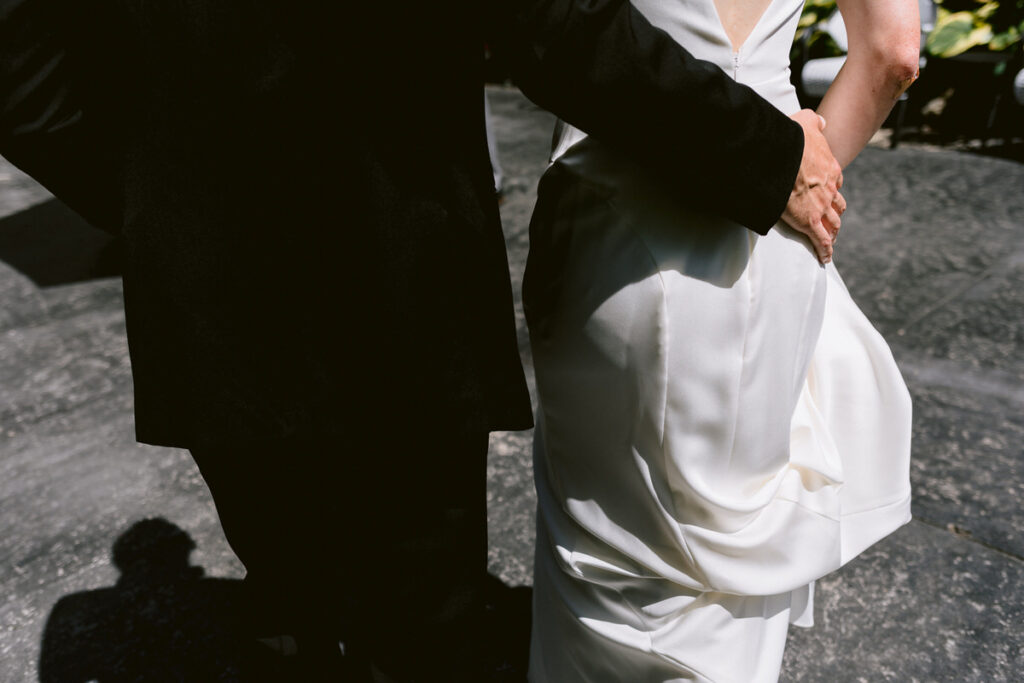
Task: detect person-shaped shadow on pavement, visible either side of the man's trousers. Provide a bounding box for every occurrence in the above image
[39,518,532,683]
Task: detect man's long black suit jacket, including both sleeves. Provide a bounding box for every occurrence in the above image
[0,0,803,446]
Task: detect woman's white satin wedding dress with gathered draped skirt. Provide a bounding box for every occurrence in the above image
[524,0,910,683]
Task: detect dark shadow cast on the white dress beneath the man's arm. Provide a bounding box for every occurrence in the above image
[523,137,754,343]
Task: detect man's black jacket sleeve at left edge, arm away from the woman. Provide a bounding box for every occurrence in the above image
[0,0,122,232]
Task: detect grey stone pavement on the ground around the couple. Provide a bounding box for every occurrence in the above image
[0,88,1024,683]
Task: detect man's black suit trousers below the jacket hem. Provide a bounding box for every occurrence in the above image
[191,424,487,681]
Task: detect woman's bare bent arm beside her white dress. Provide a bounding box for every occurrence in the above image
[818,0,921,167]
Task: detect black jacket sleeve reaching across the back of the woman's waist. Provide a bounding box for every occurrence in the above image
[488,0,804,234]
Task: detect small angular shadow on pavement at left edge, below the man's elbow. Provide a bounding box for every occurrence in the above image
[0,200,121,287]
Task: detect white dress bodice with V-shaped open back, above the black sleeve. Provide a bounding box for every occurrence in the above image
[552,0,804,159]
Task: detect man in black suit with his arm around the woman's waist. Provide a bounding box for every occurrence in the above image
[0,0,842,681]
